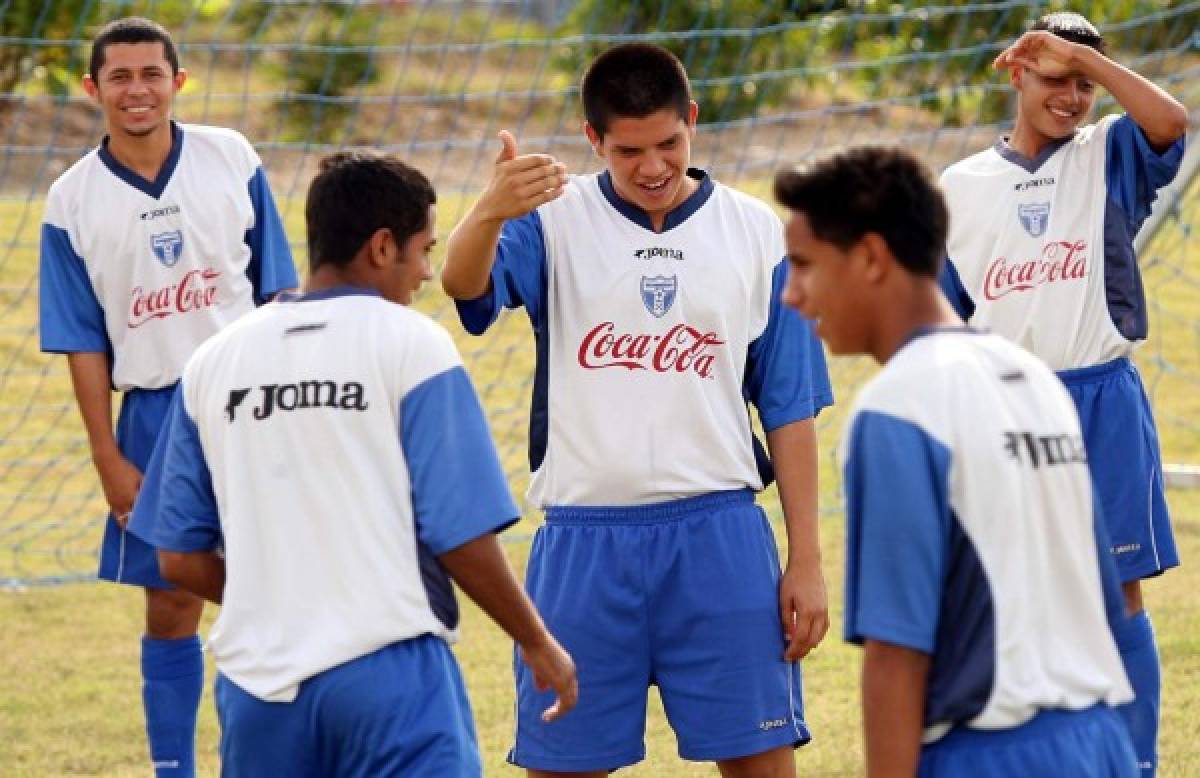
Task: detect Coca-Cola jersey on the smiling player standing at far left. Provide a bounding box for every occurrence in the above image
[40,124,296,390]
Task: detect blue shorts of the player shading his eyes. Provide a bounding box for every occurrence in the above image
[1058,358,1180,582]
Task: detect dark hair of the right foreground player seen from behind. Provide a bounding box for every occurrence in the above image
[775,146,949,277]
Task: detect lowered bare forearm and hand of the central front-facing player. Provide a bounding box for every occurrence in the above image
[767,419,829,662]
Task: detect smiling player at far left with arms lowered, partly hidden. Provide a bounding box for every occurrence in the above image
[40,18,296,777]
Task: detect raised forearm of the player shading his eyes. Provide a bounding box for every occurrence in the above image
[1074,46,1188,150]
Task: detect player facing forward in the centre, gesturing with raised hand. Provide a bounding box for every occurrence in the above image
[442,44,833,776]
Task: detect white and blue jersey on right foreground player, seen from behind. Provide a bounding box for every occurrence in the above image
[841,330,1132,743]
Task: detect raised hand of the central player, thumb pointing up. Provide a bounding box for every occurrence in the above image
[475,130,566,221]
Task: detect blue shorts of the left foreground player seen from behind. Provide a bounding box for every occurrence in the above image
[215,635,482,778]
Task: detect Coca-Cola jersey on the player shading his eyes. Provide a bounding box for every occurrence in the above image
[941,115,1183,370]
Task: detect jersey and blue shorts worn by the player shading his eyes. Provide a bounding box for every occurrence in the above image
[941,115,1184,581]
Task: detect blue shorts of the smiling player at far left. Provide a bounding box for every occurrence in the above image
[96,387,175,590]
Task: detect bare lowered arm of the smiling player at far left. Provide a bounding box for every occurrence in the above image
[67,352,142,527]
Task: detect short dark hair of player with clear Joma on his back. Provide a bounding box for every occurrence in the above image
[304,151,437,270]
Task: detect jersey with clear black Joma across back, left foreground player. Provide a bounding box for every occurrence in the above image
[132,288,518,701]
